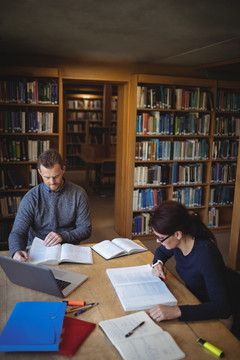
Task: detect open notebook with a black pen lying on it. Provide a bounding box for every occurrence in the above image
[99,311,185,360]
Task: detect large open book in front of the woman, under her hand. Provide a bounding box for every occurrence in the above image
[106,264,177,311]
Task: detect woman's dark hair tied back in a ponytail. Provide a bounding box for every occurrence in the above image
[149,200,216,244]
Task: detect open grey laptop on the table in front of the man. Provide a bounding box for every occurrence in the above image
[0,255,88,298]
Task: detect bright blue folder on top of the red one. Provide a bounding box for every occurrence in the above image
[0,301,67,351]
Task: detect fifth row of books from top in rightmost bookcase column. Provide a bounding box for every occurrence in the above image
[209,185,235,205]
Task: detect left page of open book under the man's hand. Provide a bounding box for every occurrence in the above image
[29,237,61,265]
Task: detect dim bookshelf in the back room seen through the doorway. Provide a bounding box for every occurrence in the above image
[64,80,118,188]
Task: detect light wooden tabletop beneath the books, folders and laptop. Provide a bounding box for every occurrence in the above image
[0,241,240,360]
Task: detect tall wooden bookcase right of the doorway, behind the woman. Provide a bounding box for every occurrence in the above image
[117,75,239,239]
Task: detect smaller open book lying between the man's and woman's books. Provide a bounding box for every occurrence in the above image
[92,238,147,260]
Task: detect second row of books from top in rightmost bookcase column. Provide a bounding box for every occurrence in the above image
[214,116,240,136]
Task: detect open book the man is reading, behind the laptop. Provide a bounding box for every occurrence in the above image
[29,237,93,265]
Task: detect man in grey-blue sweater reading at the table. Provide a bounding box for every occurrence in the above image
[8,149,92,261]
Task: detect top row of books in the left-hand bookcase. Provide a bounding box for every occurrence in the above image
[0,78,58,104]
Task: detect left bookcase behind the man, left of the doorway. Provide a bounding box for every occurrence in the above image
[0,68,61,250]
